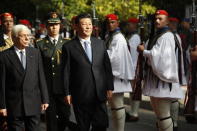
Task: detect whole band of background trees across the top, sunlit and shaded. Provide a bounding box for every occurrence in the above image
[0,0,192,21]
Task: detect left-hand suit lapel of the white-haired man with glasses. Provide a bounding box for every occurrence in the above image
[7,46,25,74]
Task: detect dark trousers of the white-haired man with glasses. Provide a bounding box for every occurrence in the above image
[7,114,40,131]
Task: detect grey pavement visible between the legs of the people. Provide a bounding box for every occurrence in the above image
[41,86,197,131]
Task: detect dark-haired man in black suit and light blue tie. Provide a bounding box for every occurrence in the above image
[62,14,113,131]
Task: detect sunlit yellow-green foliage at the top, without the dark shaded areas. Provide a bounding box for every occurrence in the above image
[48,0,156,20]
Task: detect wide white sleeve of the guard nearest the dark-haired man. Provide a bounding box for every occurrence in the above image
[107,33,135,80]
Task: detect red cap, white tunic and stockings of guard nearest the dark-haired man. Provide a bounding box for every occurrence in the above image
[106,14,134,131]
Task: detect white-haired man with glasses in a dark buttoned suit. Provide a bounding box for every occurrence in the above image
[0,25,49,131]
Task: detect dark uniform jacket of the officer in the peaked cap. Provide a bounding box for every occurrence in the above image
[36,36,67,95]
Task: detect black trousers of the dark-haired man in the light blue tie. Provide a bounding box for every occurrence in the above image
[73,102,109,131]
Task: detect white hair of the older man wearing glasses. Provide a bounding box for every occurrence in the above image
[12,24,31,37]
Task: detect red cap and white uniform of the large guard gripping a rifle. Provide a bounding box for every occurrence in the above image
[140,10,184,131]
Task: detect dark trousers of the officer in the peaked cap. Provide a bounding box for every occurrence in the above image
[46,95,70,131]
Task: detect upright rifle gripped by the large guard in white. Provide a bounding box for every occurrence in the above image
[132,0,145,100]
